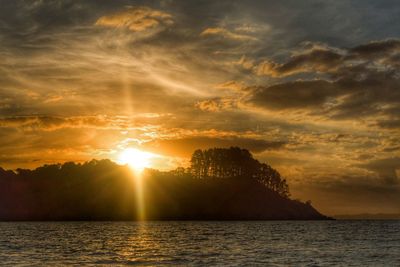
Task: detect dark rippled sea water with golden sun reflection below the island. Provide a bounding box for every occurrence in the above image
[0,221,400,266]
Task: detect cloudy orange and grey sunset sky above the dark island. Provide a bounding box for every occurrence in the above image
[0,0,400,215]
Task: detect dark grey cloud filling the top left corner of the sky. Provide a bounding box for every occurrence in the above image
[0,1,93,50]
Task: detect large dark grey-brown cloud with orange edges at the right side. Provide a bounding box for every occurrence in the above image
[249,40,400,126]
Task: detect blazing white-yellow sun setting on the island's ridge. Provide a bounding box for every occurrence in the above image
[118,148,154,171]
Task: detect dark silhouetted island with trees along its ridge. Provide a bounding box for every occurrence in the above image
[0,147,330,220]
